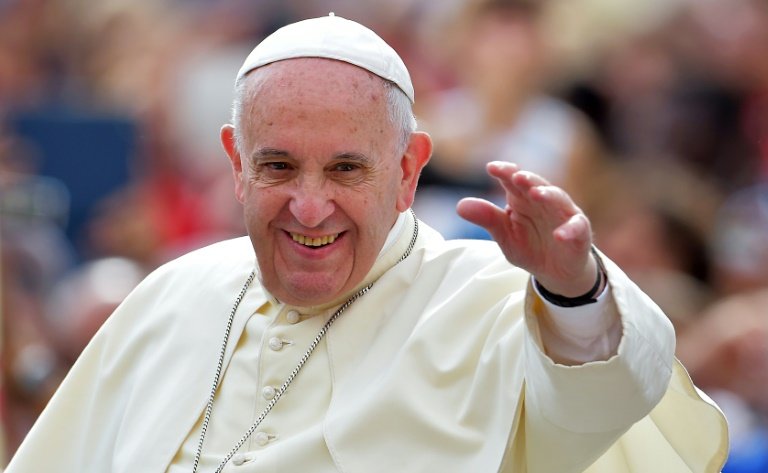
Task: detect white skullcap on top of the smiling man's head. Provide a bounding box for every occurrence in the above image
[237,13,414,103]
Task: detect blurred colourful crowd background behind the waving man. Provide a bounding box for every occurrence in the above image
[0,0,768,473]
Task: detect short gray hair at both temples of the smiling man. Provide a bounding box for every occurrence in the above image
[232,76,417,154]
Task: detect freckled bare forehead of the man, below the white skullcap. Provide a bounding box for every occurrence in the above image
[241,58,396,148]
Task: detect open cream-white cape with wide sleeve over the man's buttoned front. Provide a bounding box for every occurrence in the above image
[6,214,728,473]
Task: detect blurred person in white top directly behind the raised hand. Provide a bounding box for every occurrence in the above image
[416,0,601,237]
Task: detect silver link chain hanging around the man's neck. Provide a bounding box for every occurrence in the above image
[192,210,419,473]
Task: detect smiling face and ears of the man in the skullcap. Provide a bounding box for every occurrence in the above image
[222,58,431,306]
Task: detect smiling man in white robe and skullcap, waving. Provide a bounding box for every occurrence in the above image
[8,15,727,473]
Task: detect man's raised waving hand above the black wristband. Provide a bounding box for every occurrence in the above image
[456,161,598,297]
